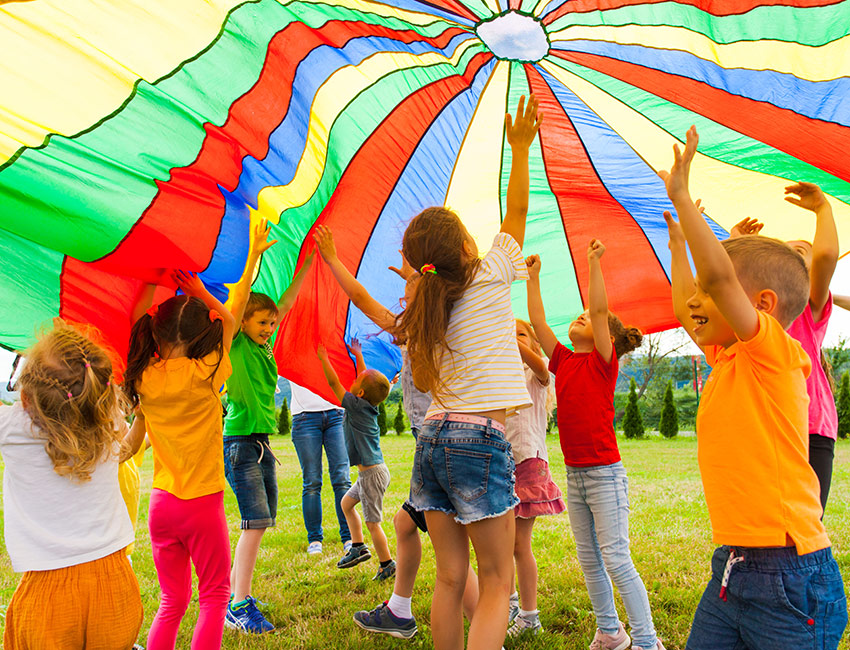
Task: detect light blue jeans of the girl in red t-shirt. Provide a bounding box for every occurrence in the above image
[567,462,658,648]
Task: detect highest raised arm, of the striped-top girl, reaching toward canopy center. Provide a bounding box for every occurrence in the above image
[502,95,543,248]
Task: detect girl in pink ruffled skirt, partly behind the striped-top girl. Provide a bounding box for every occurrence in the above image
[505,320,567,636]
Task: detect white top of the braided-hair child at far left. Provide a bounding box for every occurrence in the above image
[0,403,135,572]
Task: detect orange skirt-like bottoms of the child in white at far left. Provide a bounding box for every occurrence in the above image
[3,549,142,650]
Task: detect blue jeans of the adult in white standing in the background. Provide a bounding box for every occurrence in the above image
[292,409,351,542]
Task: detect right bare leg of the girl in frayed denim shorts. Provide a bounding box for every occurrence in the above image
[464,510,515,650]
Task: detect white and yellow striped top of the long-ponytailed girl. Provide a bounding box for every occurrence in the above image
[425,233,530,417]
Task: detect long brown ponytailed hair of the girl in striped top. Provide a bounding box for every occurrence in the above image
[390,207,479,394]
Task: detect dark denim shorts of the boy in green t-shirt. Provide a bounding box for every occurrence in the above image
[224,433,277,529]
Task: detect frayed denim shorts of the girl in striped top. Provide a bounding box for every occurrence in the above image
[410,416,519,524]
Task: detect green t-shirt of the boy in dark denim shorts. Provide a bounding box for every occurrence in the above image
[224,332,277,436]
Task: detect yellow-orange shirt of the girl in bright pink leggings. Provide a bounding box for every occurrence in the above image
[138,352,231,499]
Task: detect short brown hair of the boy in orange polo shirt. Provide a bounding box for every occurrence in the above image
[721,236,809,327]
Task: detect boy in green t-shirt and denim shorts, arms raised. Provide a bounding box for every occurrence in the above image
[224,220,313,634]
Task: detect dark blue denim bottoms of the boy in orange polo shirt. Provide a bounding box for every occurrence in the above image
[687,546,847,650]
